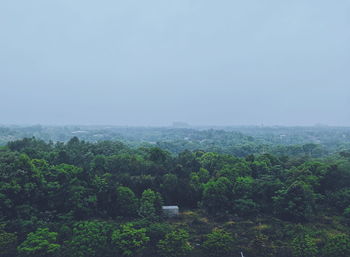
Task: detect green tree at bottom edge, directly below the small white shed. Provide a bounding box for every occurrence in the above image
[157,229,192,257]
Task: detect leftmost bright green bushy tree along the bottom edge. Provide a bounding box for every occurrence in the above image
[17,228,61,257]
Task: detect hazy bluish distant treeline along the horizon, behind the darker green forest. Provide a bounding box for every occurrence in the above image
[0,125,350,157]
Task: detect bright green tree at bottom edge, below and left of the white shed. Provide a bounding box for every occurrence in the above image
[112,223,150,256]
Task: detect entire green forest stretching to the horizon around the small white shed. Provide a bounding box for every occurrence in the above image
[0,126,350,257]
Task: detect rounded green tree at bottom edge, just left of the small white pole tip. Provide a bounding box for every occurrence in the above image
[203,229,235,257]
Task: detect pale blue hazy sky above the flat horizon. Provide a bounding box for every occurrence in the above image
[0,0,350,126]
